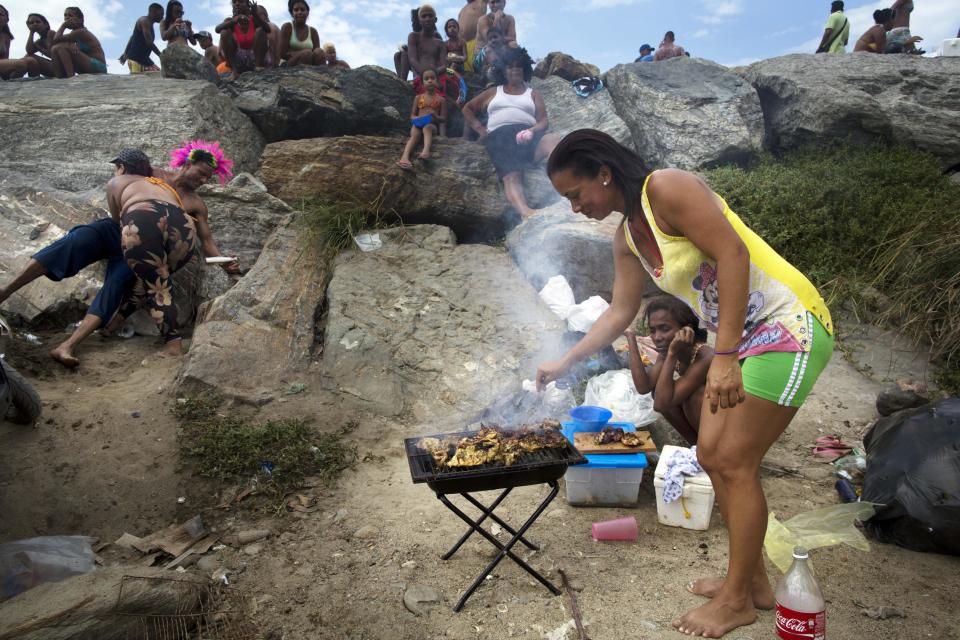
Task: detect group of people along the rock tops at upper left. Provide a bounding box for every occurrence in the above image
[0,0,350,80]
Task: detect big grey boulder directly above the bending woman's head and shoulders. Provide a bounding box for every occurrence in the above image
[606,57,763,169]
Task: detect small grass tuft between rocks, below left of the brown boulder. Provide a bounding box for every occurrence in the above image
[299,200,400,255]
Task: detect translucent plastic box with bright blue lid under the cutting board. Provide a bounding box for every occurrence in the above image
[563,422,647,507]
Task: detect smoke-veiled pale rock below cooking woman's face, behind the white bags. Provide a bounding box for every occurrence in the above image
[507,202,623,302]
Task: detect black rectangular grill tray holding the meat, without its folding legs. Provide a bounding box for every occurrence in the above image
[404,431,587,491]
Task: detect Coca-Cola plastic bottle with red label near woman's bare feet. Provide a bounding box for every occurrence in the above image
[776,547,827,640]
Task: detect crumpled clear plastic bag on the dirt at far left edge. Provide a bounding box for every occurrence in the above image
[0,536,95,599]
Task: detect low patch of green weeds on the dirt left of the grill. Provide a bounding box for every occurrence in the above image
[173,394,358,512]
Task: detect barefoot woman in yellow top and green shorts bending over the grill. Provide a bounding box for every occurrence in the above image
[537,129,833,638]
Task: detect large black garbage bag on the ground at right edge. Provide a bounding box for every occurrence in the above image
[861,398,960,555]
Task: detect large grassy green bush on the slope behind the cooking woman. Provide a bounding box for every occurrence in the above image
[705,144,960,376]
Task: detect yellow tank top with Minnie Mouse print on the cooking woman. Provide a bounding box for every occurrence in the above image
[623,173,833,358]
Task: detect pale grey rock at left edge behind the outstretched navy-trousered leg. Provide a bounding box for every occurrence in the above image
[0,185,106,329]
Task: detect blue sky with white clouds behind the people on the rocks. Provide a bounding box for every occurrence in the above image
[0,0,960,73]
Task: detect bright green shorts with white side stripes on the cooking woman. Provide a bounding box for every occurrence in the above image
[740,313,833,407]
